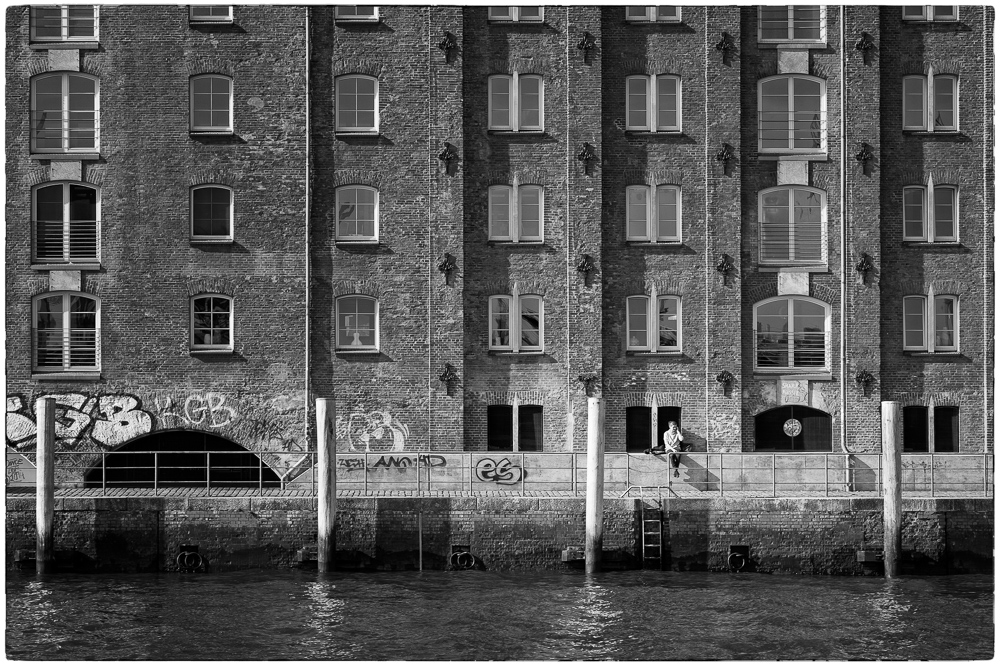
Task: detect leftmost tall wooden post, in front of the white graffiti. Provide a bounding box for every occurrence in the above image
[35,398,56,573]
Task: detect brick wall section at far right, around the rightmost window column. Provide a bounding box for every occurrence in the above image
[879,6,995,451]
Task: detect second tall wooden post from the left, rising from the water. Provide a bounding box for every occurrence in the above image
[313,398,337,572]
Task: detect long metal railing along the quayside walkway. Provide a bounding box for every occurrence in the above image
[8,451,993,498]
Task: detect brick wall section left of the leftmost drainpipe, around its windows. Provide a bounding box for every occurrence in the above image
[6,5,307,462]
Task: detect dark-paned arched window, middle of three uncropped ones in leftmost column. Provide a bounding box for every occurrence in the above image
[31,182,101,265]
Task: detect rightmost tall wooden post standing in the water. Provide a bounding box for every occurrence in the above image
[882,400,903,578]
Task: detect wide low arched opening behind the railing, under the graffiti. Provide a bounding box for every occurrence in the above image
[84,430,281,488]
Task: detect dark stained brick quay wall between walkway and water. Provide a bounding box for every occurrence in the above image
[6,495,993,575]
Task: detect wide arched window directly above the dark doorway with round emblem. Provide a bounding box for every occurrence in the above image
[753,296,830,374]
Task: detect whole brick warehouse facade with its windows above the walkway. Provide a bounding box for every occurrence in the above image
[5,5,994,472]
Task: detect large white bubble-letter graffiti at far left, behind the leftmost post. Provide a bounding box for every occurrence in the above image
[6,393,153,449]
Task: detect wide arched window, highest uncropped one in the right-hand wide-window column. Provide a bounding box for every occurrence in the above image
[757,74,826,154]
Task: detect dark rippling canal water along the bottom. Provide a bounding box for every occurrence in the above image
[6,571,994,660]
